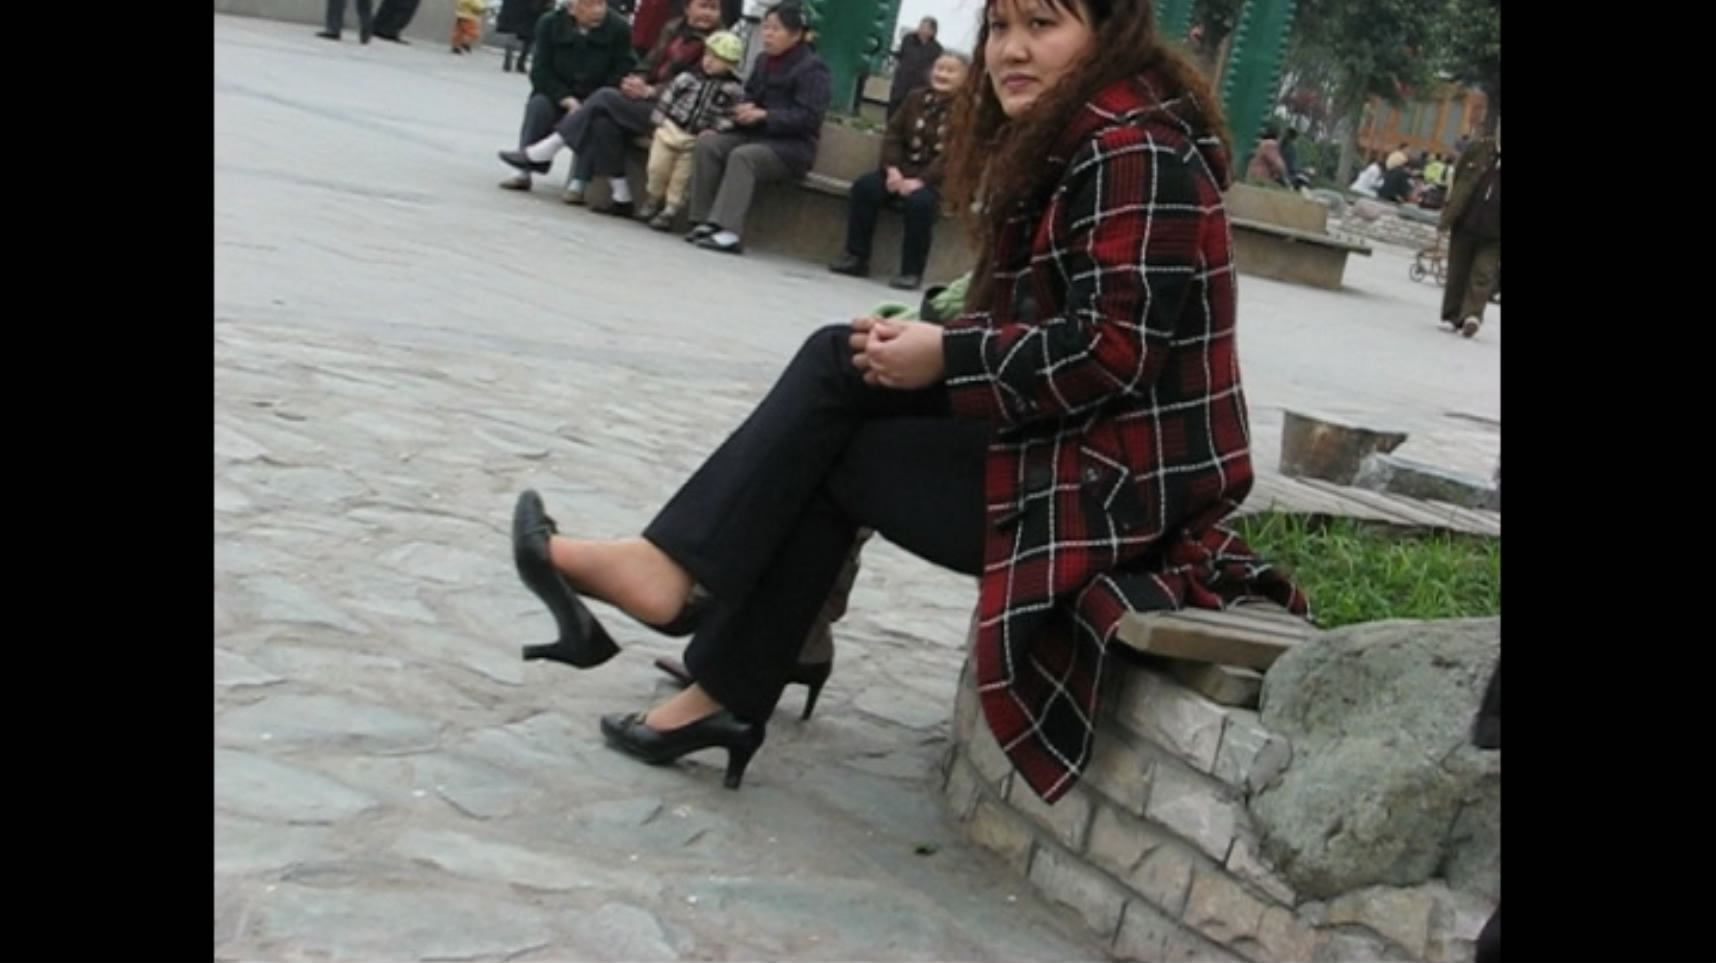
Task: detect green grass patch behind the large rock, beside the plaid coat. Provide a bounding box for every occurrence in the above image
[1234,512,1502,628]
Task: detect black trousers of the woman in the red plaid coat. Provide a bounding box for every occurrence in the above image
[644,324,990,719]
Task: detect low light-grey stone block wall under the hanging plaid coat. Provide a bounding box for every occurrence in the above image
[944,663,1491,963]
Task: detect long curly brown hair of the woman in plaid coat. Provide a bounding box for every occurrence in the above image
[944,0,1232,311]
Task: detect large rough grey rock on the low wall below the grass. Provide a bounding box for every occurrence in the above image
[1251,618,1502,899]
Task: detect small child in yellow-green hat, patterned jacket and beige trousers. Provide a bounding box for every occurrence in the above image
[638,31,745,230]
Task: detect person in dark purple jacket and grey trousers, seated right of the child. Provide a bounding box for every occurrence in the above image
[685,2,832,254]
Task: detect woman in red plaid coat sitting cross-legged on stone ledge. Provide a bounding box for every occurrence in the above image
[513,0,1306,803]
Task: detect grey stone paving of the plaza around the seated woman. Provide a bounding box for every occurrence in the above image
[215,17,1500,960]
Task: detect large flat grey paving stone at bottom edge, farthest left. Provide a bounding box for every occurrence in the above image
[247,882,554,960]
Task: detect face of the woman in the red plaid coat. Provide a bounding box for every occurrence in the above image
[983,0,1095,117]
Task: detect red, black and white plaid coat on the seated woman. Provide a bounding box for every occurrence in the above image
[942,74,1308,803]
